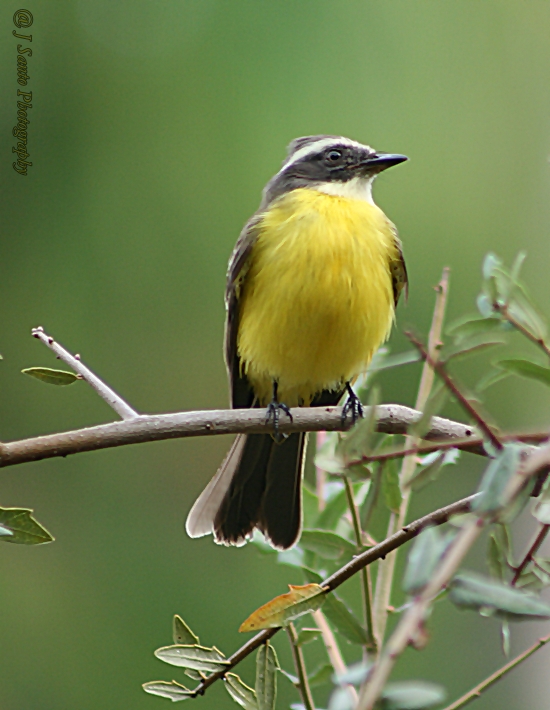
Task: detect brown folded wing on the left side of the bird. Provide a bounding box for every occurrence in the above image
[224,214,262,409]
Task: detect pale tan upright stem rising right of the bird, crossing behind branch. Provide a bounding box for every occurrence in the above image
[374,267,449,646]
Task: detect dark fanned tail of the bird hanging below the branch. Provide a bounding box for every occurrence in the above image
[186,434,306,550]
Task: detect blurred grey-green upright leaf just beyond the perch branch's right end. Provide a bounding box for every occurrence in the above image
[472,443,525,515]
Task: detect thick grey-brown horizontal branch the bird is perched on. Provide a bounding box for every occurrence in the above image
[0,404,484,468]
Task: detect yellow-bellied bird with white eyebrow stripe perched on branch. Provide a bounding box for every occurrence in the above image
[186,135,408,550]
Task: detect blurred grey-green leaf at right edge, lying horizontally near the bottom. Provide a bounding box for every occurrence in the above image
[449,573,550,621]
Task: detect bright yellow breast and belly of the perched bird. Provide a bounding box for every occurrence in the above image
[237,188,397,406]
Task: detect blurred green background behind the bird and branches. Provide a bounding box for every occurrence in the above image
[0,0,550,710]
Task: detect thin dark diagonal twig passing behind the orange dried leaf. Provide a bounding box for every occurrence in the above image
[193,495,475,695]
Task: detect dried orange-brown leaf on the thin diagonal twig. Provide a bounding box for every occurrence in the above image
[239,584,327,631]
